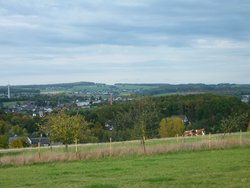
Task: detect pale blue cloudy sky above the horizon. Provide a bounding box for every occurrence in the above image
[0,0,250,85]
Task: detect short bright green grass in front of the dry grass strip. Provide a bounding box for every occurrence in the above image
[0,148,250,188]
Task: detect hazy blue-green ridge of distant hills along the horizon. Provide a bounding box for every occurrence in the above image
[0,82,250,96]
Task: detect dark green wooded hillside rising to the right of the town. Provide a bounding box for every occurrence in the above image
[79,94,250,141]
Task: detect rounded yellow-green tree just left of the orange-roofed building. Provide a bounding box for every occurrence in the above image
[159,117,185,137]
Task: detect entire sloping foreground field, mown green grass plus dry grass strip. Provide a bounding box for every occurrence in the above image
[0,133,250,188]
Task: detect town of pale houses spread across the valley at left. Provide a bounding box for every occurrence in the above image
[0,83,250,117]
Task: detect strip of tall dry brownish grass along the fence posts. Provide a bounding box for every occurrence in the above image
[0,133,250,166]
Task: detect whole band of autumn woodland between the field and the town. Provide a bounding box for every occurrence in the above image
[0,94,250,148]
